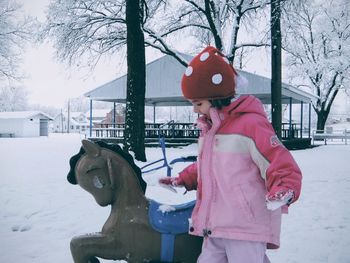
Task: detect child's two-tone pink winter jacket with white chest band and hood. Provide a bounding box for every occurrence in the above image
[179,96,302,248]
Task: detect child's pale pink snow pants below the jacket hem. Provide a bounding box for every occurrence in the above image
[197,238,270,263]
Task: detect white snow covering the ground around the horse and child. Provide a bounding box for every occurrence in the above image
[0,134,350,263]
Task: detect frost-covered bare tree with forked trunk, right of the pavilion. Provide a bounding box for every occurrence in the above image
[284,0,350,130]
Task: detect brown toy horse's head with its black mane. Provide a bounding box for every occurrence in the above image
[67,140,146,206]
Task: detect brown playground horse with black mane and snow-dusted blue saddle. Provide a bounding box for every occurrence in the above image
[67,140,202,263]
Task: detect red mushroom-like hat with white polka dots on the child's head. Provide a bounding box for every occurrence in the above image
[181,46,237,100]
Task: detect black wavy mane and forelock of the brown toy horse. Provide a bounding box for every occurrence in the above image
[67,141,147,193]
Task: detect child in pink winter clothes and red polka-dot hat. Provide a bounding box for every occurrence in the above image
[159,46,302,263]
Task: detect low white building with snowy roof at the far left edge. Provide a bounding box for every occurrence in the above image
[0,111,52,137]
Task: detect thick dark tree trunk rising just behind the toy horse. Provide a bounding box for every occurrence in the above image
[124,0,146,161]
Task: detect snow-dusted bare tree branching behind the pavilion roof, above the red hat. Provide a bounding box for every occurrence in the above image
[144,0,270,66]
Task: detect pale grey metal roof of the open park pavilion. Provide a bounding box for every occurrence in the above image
[84,54,316,106]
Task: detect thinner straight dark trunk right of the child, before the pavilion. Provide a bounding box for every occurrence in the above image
[270,0,282,138]
